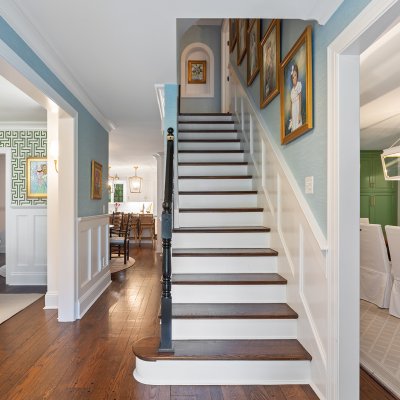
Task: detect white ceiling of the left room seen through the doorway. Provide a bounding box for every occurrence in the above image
[0,75,47,124]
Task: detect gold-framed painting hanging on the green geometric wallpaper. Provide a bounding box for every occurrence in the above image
[26,157,47,199]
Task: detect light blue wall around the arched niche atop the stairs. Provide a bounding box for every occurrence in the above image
[177,25,221,113]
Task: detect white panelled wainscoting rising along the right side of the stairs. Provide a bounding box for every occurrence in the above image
[231,69,328,399]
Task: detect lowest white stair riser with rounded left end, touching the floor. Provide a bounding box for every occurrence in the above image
[133,358,310,385]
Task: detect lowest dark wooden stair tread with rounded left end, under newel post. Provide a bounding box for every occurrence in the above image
[133,337,311,361]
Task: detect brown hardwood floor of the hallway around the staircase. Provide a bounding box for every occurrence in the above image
[0,247,394,400]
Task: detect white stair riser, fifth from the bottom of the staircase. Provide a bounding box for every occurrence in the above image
[172,232,269,249]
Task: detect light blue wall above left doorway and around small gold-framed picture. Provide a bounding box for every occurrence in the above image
[0,17,108,217]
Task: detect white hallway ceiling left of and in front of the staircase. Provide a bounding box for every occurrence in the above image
[0,0,343,166]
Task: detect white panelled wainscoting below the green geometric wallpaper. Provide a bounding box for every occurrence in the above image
[6,207,47,285]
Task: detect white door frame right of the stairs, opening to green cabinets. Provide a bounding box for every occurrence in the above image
[327,0,400,400]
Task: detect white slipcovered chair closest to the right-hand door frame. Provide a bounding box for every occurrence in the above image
[360,224,393,308]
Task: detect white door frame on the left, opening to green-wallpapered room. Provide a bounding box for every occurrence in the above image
[0,40,78,321]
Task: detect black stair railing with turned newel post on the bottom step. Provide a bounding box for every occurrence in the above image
[159,128,174,352]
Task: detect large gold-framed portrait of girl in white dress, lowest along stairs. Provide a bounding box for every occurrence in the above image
[280,25,313,144]
